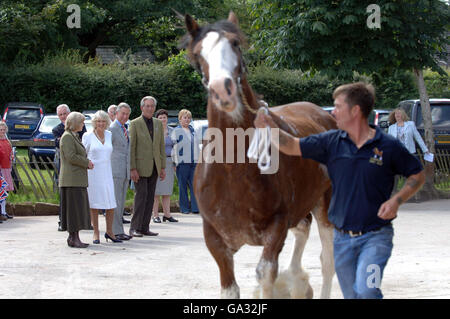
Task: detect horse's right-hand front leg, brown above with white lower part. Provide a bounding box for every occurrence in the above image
[256,218,288,299]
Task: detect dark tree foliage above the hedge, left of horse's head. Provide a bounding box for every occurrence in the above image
[0,0,250,63]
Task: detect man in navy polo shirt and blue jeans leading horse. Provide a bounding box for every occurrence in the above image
[254,82,425,298]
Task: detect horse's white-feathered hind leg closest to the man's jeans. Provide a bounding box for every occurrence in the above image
[313,189,335,299]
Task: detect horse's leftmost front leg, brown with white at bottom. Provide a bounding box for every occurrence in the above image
[203,219,240,299]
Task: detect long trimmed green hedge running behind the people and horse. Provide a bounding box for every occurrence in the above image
[0,53,450,118]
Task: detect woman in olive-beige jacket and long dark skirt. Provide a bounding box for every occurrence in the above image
[59,112,94,248]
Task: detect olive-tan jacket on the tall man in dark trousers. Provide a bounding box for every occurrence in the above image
[129,115,166,177]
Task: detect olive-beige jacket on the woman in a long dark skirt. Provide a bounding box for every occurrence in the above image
[59,131,89,187]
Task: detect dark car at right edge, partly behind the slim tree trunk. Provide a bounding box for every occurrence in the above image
[398,99,450,150]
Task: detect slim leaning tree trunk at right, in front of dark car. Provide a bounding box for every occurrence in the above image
[413,69,439,201]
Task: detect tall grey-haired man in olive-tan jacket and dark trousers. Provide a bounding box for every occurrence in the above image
[130,96,166,237]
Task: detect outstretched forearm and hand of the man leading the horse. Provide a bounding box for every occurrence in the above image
[254,112,302,156]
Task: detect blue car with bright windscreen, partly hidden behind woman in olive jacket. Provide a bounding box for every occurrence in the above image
[28,114,61,161]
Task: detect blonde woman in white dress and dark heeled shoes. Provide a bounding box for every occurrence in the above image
[83,111,121,244]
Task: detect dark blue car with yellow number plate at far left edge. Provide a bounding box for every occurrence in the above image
[3,102,45,140]
